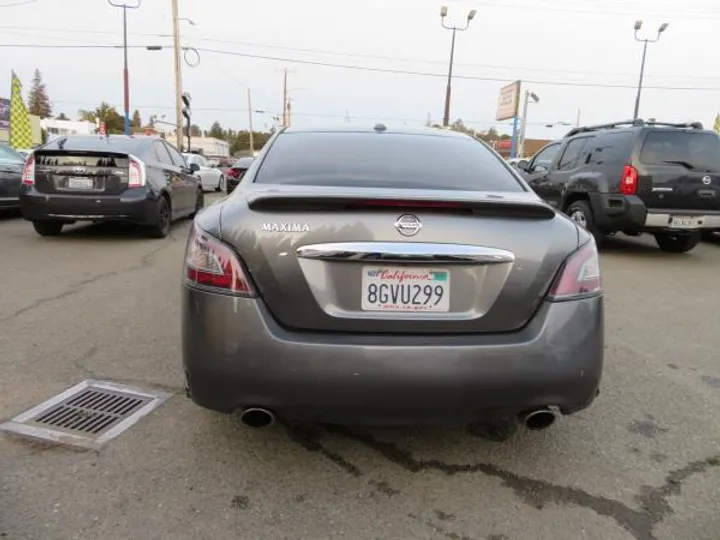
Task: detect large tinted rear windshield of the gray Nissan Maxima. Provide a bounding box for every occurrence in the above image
[255,133,524,192]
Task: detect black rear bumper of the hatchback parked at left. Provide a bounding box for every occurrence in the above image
[20,188,157,224]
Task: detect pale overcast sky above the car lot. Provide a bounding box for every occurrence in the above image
[0,0,720,138]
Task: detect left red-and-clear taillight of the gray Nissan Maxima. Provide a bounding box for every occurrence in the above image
[185,226,253,296]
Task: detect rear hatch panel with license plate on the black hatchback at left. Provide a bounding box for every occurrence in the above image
[33,150,130,196]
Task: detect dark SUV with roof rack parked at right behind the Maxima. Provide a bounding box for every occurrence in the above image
[518,119,720,253]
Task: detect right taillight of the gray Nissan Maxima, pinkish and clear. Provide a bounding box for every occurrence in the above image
[548,239,602,300]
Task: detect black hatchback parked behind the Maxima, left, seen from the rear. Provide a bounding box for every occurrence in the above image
[20,135,204,238]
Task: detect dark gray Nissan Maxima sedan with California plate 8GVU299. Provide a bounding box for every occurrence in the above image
[182,125,604,429]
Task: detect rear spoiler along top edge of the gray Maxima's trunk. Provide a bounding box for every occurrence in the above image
[246,192,556,219]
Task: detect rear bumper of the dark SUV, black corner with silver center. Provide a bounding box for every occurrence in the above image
[590,193,720,232]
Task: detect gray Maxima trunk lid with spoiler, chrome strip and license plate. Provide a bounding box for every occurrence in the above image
[222,187,578,334]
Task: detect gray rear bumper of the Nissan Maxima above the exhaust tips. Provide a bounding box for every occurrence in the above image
[182,286,604,424]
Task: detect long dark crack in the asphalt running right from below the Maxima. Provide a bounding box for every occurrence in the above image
[288,425,720,540]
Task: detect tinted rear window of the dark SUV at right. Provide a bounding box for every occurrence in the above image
[640,131,720,172]
